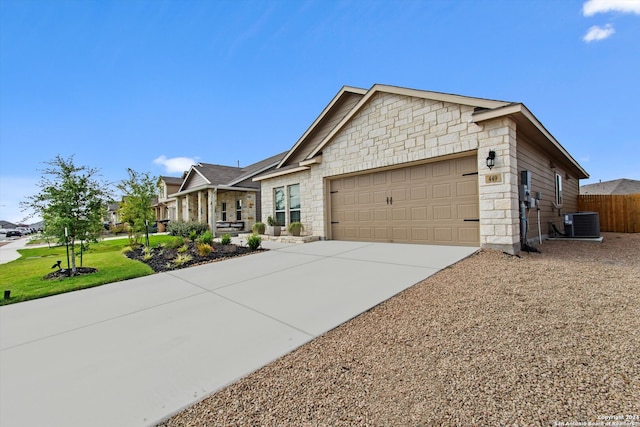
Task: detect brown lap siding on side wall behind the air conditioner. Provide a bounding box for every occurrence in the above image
[517,135,580,240]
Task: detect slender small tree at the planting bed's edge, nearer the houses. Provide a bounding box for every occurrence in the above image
[117,168,157,245]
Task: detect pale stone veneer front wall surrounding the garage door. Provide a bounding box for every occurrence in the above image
[262,93,519,253]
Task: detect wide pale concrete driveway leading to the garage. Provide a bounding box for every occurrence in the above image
[0,241,478,427]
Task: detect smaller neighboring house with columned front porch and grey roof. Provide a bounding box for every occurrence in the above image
[169,153,285,233]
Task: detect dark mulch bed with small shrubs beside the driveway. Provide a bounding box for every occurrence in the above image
[126,242,267,273]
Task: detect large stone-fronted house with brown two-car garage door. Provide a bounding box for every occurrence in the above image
[255,85,588,254]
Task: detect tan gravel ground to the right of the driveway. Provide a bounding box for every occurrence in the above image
[162,233,640,426]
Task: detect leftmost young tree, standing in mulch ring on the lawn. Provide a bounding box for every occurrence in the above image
[22,155,111,275]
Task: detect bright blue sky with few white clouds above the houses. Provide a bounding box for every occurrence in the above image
[0,0,640,222]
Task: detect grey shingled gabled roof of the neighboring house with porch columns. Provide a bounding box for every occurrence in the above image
[173,152,286,196]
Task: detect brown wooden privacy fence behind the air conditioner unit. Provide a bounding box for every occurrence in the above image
[578,194,640,233]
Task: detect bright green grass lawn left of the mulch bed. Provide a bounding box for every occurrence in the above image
[0,235,172,305]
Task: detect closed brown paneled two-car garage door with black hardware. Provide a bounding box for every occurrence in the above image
[330,156,480,246]
